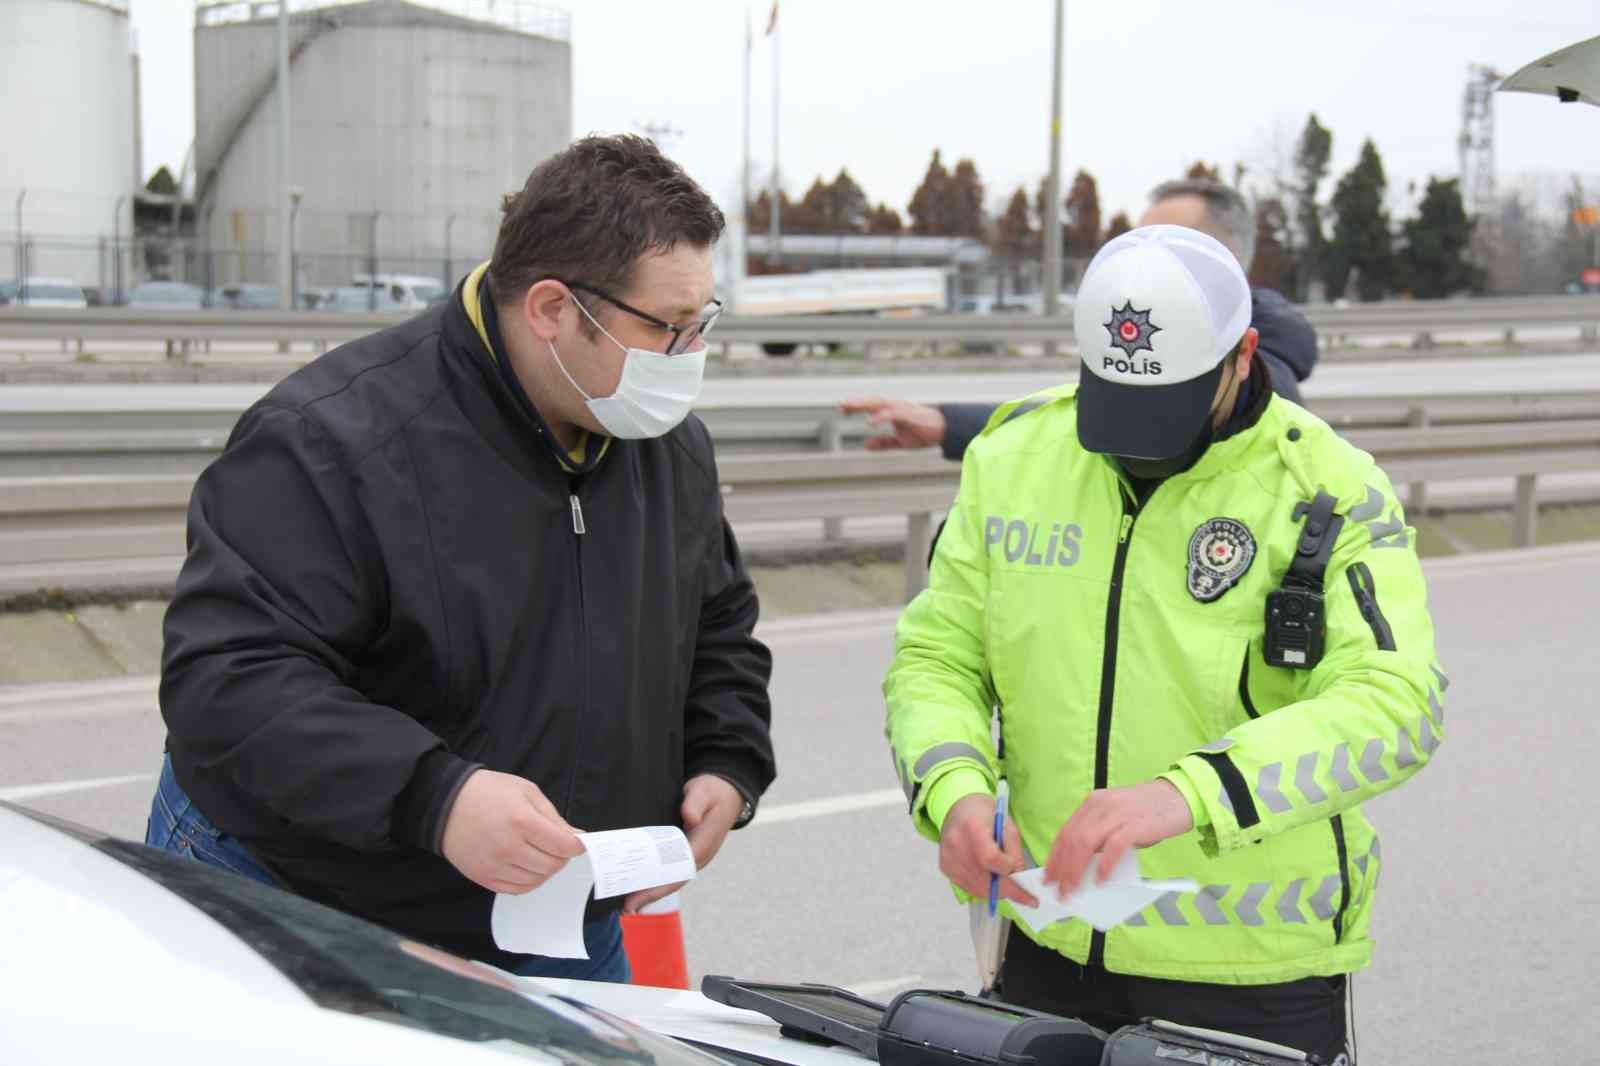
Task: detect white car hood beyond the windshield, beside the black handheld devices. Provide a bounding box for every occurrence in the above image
[512,976,874,1066]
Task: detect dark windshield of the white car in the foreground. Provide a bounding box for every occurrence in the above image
[68,820,718,1066]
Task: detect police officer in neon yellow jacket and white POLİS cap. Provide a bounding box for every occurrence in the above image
[885,226,1446,1061]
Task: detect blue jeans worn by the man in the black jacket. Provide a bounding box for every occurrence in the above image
[144,755,632,984]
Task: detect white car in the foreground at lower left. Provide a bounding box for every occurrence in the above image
[0,802,864,1066]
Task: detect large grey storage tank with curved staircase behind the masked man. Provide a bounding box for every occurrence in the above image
[195,0,573,290]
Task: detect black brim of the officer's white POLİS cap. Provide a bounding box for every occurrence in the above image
[1077,360,1226,459]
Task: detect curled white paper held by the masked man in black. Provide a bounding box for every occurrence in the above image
[490,826,694,959]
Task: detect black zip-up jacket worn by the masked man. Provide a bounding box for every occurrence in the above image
[162,290,774,965]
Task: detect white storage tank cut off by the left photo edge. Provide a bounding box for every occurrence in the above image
[0,0,138,287]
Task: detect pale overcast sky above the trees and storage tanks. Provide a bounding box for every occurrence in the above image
[131,0,1600,219]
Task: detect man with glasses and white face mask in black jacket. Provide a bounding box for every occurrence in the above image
[147,136,774,980]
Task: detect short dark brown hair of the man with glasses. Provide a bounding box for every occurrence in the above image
[488,133,726,304]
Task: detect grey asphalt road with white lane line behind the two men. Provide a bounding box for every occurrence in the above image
[0,547,1600,1063]
